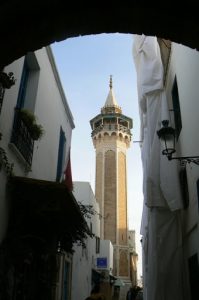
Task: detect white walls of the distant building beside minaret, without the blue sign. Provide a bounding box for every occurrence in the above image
[71,182,113,300]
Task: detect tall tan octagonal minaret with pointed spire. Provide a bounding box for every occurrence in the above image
[90,76,132,279]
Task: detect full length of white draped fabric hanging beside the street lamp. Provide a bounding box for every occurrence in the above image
[133,35,183,300]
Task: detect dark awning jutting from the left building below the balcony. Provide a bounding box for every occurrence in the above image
[8,176,89,251]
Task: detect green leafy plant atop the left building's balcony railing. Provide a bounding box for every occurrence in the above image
[20,109,44,141]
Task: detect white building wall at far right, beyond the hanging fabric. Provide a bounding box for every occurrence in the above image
[162,43,199,299]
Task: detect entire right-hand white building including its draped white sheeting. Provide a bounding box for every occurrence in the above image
[133,35,199,300]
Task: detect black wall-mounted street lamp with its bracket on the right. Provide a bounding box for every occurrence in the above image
[157,120,199,165]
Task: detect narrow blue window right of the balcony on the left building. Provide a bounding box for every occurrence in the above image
[56,127,66,181]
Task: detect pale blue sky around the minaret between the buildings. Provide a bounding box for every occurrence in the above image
[51,33,143,272]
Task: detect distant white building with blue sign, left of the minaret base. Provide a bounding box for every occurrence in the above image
[71,182,113,300]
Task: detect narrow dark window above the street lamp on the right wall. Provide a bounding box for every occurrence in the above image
[172,77,182,140]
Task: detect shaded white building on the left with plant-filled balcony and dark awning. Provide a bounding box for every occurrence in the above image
[0,46,86,300]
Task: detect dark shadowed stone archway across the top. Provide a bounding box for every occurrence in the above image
[0,0,199,67]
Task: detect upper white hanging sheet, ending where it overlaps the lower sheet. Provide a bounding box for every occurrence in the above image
[133,35,182,211]
